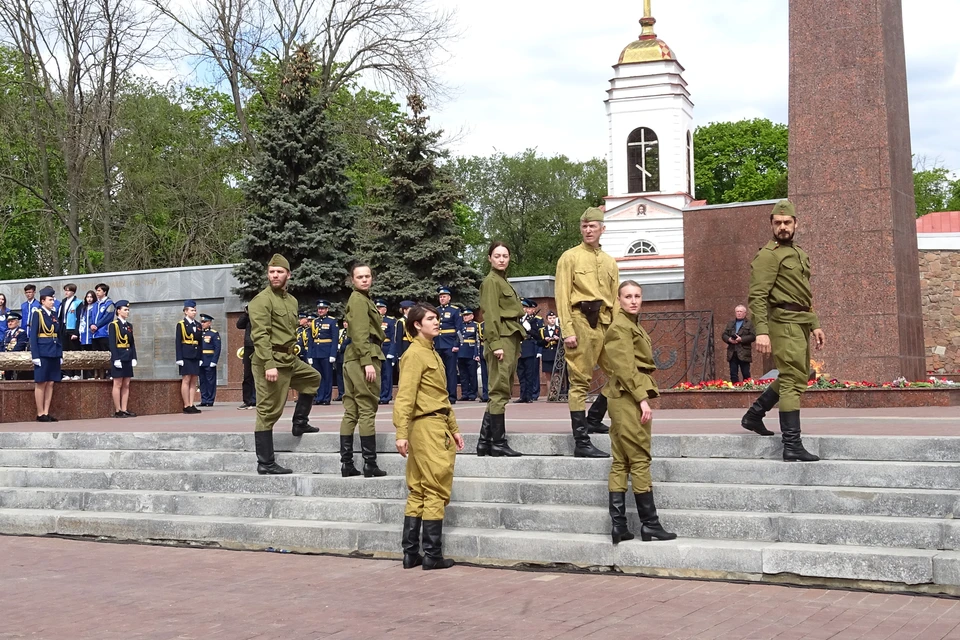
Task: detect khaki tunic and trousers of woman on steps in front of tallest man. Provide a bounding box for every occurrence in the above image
[602,309,660,493]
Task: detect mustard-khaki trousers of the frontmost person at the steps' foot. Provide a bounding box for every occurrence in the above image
[403,416,457,520]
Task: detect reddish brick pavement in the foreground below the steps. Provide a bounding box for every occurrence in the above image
[0,537,960,640]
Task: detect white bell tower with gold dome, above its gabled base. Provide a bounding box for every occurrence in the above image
[605,0,694,211]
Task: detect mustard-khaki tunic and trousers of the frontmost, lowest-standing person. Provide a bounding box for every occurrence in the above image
[393,336,460,520]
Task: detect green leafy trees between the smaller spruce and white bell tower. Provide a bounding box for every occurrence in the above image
[454,154,607,276]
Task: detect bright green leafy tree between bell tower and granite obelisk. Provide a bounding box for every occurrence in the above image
[693,119,788,204]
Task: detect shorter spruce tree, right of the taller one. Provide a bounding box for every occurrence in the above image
[359,95,480,308]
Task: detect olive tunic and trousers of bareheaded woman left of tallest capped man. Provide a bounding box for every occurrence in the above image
[480,269,524,415]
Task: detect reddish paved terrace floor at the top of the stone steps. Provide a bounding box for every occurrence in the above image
[0,402,960,436]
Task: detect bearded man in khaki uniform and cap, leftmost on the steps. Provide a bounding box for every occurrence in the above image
[247,253,320,474]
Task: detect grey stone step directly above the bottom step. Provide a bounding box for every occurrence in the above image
[0,488,960,549]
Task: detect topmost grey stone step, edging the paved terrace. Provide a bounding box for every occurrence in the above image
[0,432,960,462]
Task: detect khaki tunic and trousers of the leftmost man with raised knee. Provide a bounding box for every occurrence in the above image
[247,286,320,431]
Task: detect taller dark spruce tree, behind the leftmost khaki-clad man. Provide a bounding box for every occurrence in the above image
[233,47,358,306]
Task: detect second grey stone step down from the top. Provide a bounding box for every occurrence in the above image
[0,449,960,489]
